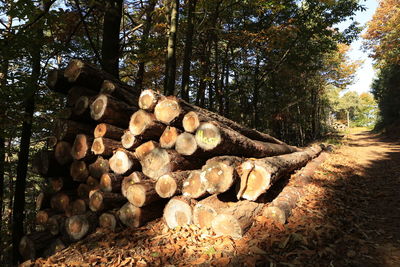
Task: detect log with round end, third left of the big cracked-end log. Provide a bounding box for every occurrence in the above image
[155,171,194,198]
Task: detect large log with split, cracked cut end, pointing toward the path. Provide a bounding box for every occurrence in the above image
[237,146,322,201]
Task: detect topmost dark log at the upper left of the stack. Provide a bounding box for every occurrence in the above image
[64,59,115,92]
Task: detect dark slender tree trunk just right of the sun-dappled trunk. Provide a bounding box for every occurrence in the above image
[181,0,197,101]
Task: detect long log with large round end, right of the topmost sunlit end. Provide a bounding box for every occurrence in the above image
[154,93,283,144]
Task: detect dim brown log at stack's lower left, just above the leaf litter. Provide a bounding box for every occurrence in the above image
[65,212,98,241]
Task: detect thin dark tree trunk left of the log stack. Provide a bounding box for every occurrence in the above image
[12,28,43,264]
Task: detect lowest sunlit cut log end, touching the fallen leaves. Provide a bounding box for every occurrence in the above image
[211,214,243,239]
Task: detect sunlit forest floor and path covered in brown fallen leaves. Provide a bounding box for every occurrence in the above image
[30,129,400,266]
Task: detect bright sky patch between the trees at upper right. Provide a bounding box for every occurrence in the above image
[338,0,379,94]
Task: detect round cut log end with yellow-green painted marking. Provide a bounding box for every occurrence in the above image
[195,123,222,151]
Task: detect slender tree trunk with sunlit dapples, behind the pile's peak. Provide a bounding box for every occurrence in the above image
[164,0,179,95]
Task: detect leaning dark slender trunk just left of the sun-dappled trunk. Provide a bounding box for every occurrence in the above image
[135,0,157,91]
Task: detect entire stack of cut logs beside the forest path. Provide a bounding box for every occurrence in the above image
[20,60,321,259]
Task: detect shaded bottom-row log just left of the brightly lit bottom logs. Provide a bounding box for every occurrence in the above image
[117,202,165,228]
